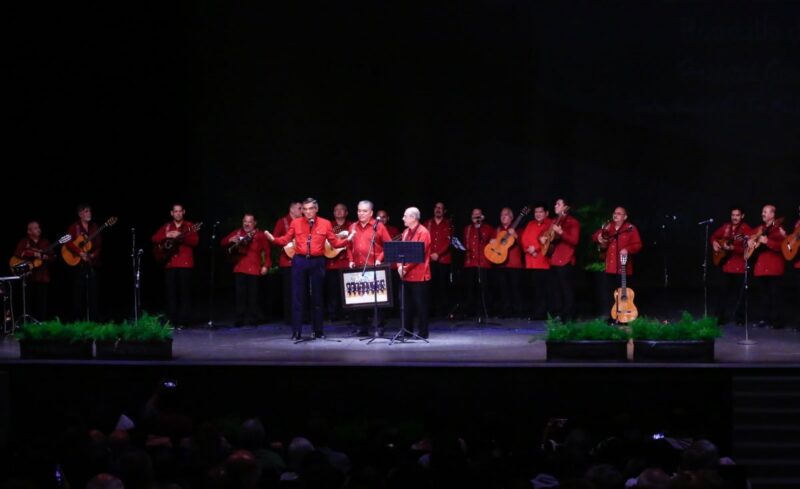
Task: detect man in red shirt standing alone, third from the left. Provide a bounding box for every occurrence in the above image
[151,204,200,327]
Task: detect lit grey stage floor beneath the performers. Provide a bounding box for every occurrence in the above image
[0,319,800,368]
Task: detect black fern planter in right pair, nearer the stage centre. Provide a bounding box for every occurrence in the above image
[545,319,630,362]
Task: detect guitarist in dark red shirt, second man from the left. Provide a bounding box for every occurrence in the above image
[64,204,103,321]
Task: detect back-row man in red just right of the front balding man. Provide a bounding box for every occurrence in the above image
[424,202,455,317]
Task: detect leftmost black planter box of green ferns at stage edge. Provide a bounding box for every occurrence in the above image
[14,319,96,359]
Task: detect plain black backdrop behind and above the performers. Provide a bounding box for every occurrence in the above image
[6,0,800,322]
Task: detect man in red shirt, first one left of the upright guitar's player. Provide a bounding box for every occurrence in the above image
[550,199,581,321]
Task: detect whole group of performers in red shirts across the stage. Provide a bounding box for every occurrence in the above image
[6,198,800,340]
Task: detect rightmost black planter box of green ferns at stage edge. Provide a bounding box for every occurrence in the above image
[630,311,722,362]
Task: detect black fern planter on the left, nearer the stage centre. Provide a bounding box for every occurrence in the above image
[93,313,172,360]
